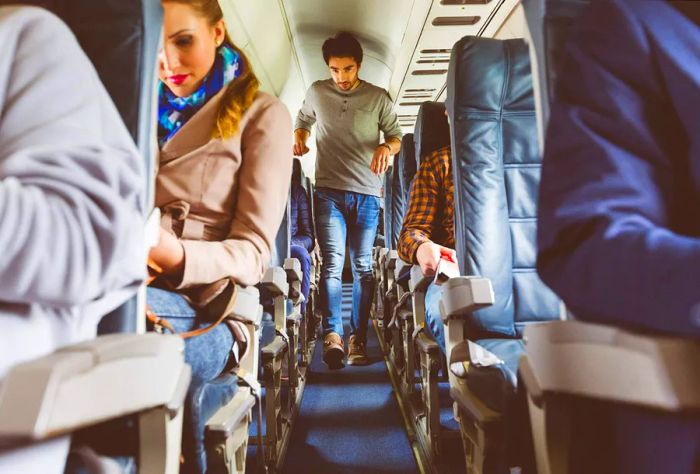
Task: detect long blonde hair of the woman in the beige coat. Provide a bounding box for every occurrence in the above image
[161,0,260,139]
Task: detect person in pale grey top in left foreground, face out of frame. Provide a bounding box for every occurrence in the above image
[0,7,146,473]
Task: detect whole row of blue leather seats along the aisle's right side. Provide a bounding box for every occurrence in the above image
[372,0,700,473]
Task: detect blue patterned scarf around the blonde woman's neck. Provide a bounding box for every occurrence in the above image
[158,43,241,148]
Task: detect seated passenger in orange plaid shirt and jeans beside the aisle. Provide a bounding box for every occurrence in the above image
[397,147,457,353]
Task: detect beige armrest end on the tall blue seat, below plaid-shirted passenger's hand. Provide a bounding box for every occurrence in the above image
[440,275,495,321]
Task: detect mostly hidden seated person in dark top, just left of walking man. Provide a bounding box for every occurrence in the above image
[290,162,315,314]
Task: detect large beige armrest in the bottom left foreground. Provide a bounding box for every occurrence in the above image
[0,333,190,445]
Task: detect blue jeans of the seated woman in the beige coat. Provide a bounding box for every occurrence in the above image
[146,286,233,385]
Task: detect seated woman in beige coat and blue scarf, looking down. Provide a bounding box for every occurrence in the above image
[147,0,292,386]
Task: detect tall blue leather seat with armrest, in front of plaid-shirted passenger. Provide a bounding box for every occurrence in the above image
[441,37,560,472]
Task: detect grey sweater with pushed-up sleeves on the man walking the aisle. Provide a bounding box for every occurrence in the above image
[295,79,401,196]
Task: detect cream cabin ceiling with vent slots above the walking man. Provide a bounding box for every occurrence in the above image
[282,0,518,132]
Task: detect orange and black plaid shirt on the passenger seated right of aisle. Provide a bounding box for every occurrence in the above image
[397,147,455,263]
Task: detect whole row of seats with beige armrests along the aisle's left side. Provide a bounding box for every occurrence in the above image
[0,0,320,473]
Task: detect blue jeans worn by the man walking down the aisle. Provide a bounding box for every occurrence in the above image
[314,188,379,341]
